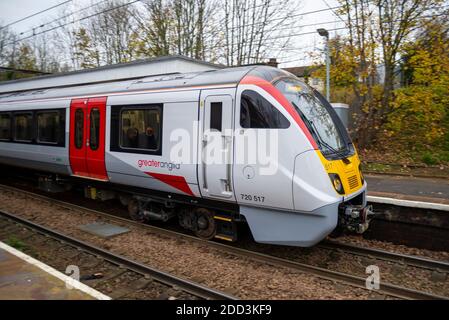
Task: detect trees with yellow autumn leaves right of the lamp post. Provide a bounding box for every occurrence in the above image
[314,0,449,168]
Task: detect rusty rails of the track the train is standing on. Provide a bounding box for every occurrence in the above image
[0,185,449,300]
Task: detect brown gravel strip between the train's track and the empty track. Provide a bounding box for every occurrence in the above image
[0,191,377,299]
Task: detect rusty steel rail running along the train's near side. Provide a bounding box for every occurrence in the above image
[0,184,449,300]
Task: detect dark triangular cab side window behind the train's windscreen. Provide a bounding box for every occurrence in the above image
[240,90,290,129]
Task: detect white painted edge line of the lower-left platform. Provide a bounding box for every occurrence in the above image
[0,241,111,300]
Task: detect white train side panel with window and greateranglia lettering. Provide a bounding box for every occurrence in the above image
[106,90,200,197]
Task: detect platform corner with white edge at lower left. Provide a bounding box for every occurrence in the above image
[0,242,110,300]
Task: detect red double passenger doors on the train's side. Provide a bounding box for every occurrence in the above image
[70,97,108,181]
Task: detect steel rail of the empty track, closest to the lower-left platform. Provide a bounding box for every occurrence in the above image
[0,210,237,300]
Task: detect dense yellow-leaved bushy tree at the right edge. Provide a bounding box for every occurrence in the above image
[382,21,449,164]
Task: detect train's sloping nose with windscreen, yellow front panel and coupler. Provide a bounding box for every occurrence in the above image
[236,68,373,246]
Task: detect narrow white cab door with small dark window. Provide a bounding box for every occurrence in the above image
[198,94,235,201]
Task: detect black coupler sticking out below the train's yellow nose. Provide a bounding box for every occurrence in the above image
[339,205,375,234]
